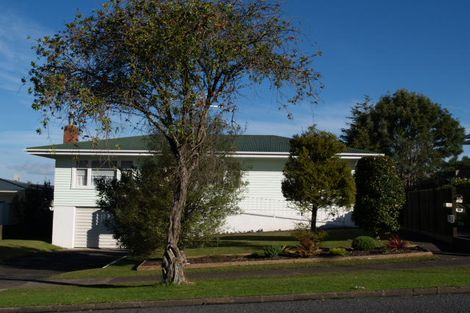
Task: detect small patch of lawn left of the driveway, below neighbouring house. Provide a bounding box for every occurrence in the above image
[0,239,61,262]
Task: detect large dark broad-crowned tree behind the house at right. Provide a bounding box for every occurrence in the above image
[341,89,465,189]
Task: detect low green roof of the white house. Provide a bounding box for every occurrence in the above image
[28,135,374,153]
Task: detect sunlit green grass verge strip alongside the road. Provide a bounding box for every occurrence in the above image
[0,266,470,307]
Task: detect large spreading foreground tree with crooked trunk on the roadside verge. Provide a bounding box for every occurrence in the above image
[30,0,318,284]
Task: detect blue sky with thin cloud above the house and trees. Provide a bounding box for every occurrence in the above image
[0,0,470,182]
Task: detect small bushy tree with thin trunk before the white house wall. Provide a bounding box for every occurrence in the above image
[282,127,355,231]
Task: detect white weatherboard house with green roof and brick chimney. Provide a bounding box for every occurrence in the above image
[26,129,377,248]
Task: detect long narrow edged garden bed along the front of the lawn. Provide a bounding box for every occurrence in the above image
[137,247,432,271]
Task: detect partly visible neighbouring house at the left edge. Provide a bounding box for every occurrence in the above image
[0,178,29,225]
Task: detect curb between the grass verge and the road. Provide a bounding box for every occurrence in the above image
[0,286,470,313]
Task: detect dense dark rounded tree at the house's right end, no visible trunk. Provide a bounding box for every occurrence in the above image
[353,156,405,236]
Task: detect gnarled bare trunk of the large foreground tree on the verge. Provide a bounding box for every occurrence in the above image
[162,167,189,285]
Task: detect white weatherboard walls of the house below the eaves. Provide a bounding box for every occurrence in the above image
[52,157,352,248]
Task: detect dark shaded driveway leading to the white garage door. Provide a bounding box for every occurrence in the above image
[0,249,125,290]
